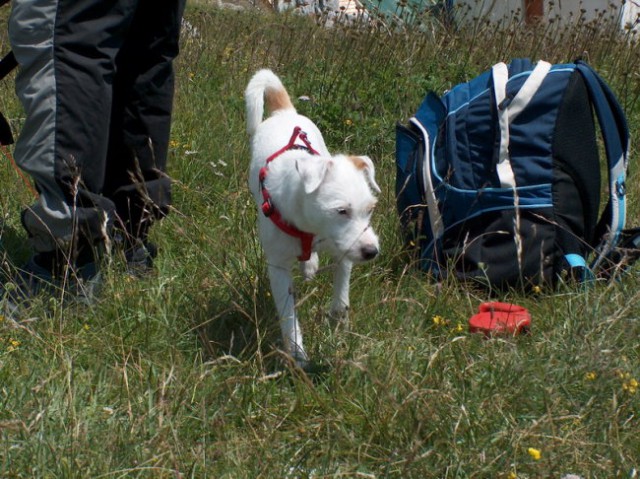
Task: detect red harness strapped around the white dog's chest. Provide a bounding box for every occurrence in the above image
[258,126,320,261]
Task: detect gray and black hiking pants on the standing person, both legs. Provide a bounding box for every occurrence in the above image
[9,0,186,252]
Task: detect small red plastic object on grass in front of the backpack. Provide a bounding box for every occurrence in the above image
[469,302,531,336]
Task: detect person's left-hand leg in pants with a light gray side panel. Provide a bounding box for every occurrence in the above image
[9,0,137,284]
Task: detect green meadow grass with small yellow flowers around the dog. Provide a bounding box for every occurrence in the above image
[0,5,640,479]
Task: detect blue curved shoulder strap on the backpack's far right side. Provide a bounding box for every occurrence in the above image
[576,61,629,270]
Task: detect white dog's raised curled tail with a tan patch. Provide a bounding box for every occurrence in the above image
[244,69,295,135]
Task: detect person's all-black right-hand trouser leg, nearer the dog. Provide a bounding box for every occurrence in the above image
[104,0,185,261]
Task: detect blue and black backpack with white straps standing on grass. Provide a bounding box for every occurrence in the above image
[396,59,640,287]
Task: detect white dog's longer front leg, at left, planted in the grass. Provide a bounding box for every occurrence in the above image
[269,264,308,367]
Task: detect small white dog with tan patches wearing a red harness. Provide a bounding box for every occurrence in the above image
[245,70,380,367]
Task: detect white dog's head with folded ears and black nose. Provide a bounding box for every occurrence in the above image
[296,155,380,262]
